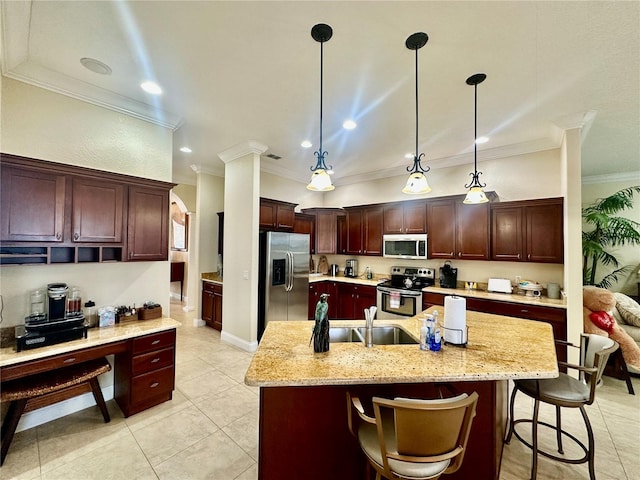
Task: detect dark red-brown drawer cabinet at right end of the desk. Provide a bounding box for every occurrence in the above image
[114,330,176,417]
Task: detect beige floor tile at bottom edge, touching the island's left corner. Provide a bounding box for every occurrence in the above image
[155,430,255,480]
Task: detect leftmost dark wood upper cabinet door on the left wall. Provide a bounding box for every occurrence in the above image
[0,167,66,242]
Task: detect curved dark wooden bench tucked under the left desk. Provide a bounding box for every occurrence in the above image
[0,357,111,465]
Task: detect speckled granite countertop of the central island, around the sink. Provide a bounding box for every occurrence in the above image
[245,306,558,387]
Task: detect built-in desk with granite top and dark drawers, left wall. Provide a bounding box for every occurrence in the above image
[0,317,180,417]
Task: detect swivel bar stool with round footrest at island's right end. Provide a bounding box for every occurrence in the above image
[505,333,618,480]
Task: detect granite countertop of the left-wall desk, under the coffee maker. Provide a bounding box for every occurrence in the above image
[0,317,181,367]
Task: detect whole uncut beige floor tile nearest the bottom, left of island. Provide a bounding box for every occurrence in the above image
[133,406,218,466]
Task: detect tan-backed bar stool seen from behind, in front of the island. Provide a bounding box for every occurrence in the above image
[347,392,478,480]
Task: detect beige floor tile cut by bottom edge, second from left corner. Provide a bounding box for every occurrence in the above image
[42,433,157,480]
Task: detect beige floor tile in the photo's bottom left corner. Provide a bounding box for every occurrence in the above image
[0,428,40,480]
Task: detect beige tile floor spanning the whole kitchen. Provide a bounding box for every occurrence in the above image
[0,303,640,480]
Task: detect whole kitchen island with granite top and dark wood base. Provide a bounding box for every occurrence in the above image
[245,307,558,480]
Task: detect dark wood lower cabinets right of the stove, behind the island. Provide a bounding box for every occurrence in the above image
[422,292,567,362]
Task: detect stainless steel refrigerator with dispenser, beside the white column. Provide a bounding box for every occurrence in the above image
[258,232,309,339]
